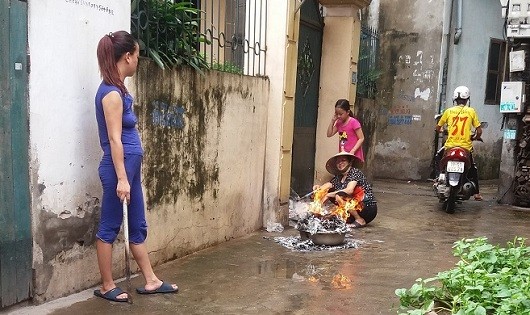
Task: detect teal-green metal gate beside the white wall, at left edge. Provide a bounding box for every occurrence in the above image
[0,0,32,309]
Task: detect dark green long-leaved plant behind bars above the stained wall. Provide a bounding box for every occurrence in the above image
[131,0,209,72]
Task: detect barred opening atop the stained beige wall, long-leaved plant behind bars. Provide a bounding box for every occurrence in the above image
[131,0,268,75]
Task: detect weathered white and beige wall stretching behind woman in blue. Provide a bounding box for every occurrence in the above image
[29,0,269,303]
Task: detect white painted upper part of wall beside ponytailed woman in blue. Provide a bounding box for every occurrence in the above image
[29,0,130,213]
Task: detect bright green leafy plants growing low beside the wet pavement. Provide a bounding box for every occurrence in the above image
[395,237,530,315]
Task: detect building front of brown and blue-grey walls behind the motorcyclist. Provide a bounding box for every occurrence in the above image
[361,0,504,180]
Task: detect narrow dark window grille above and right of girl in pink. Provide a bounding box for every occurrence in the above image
[357,25,381,99]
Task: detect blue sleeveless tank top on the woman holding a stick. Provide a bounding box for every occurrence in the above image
[95,82,144,157]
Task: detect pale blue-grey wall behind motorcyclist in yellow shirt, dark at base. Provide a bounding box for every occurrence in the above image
[446,0,504,179]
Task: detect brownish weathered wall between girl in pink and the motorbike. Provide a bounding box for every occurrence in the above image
[370,0,443,179]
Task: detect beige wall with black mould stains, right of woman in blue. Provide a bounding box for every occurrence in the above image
[133,60,269,264]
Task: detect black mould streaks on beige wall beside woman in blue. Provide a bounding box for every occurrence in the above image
[136,64,252,209]
